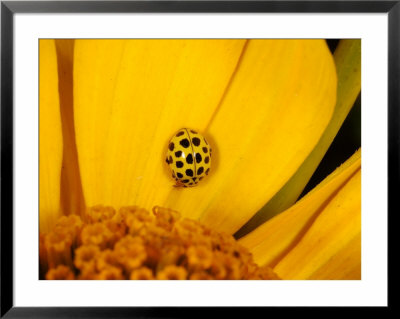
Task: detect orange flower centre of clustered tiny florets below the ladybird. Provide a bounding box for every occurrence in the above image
[39,206,279,280]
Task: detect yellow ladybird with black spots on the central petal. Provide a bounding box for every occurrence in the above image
[166,128,211,187]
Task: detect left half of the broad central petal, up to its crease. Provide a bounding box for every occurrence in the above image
[74,40,246,209]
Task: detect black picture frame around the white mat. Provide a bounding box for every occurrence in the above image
[0,1,394,318]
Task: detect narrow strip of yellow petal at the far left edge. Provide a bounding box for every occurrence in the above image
[39,40,63,232]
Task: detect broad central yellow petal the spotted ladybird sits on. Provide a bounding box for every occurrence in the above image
[74,40,336,233]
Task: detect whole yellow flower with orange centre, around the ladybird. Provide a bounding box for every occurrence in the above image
[40,39,361,279]
